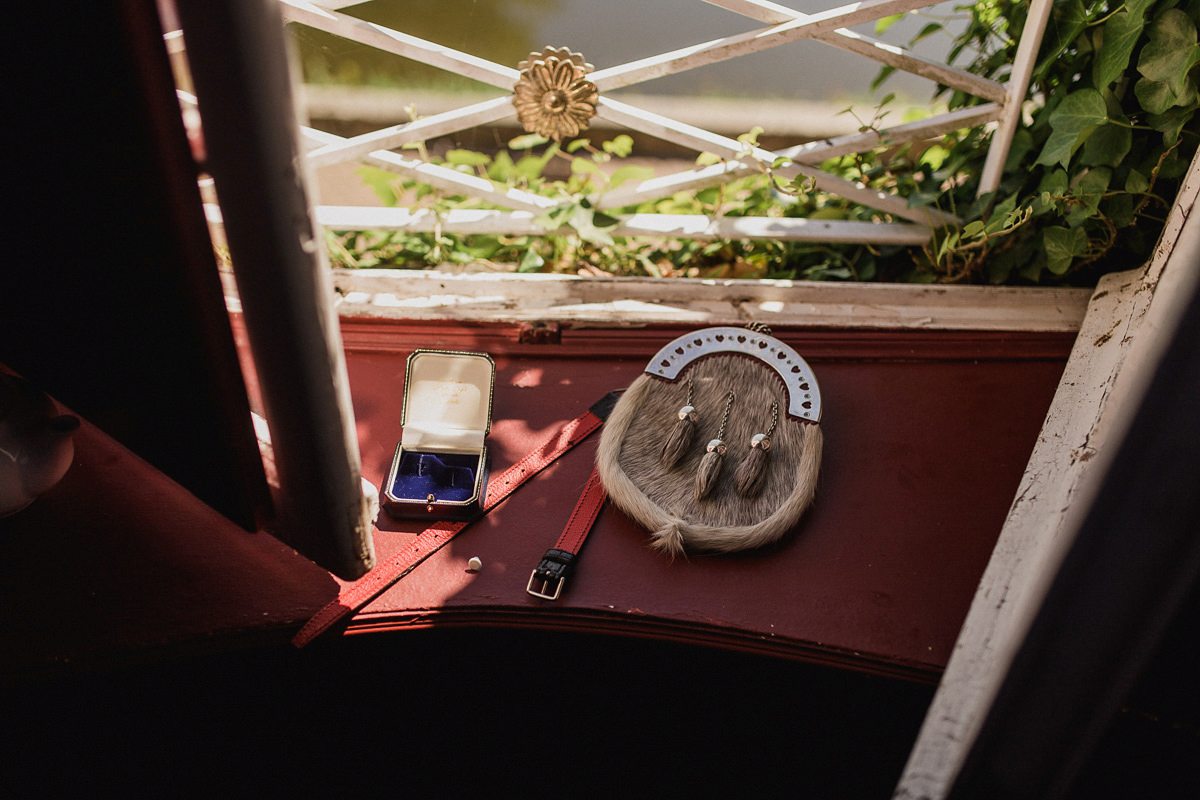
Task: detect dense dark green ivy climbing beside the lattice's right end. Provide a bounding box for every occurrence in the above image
[918,0,1200,283]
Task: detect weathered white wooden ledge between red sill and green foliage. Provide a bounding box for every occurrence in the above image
[334,270,1092,332]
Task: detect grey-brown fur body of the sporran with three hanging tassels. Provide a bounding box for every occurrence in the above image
[596,329,822,555]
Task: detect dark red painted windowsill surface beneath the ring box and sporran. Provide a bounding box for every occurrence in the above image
[0,319,1073,680]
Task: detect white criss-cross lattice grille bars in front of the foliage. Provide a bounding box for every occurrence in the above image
[280,0,1052,245]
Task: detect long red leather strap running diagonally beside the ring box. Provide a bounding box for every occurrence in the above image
[292,392,617,648]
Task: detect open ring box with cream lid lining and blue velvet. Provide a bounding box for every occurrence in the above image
[380,350,496,519]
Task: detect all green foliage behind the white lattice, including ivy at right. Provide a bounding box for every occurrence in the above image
[329,0,1200,284]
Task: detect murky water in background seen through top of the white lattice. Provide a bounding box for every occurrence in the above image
[294,0,964,102]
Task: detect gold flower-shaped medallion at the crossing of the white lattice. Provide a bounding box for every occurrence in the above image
[512,47,600,142]
